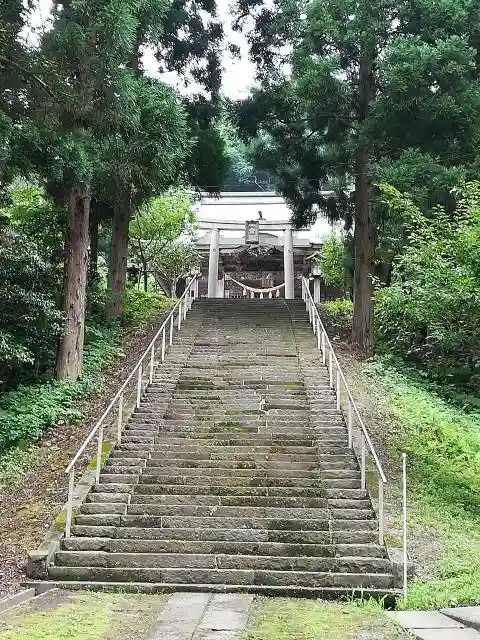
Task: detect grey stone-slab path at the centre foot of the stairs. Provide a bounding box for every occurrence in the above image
[148,593,253,640]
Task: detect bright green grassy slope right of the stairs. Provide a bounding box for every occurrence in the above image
[364,360,480,609]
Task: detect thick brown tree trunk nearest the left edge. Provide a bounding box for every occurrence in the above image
[57,185,91,380]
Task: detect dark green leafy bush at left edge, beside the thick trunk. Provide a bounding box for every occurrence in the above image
[0,232,62,390]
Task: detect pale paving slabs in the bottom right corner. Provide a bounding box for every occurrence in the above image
[388,607,480,640]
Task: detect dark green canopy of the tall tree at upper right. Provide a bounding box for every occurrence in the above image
[237,0,480,226]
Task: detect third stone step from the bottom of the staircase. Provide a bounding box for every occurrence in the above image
[55,551,390,573]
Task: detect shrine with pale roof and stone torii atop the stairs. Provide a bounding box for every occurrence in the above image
[196,192,338,302]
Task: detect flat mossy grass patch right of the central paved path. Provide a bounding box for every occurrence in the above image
[241,598,406,640]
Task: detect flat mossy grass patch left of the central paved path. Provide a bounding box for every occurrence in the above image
[0,592,165,640]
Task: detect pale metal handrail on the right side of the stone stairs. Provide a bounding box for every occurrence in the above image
[302,277,387,544]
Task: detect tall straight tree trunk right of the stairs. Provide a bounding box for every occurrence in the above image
[352,57,374,354]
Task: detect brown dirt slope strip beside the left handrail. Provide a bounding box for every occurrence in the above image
[0,314,172,597]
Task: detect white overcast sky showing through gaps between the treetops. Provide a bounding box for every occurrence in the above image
[29,0,254,99]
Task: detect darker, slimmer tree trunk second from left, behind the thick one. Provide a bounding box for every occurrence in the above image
[105,200,131,317]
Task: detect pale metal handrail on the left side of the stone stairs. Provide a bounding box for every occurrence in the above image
[65,276,198,538]
